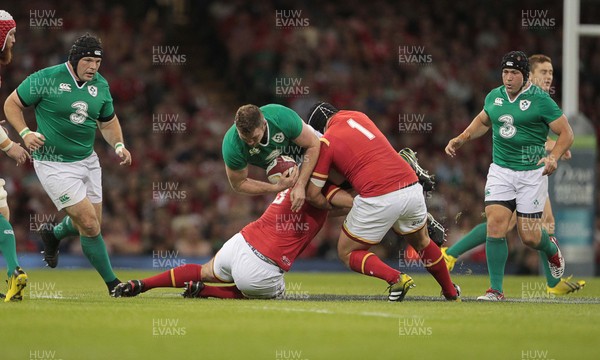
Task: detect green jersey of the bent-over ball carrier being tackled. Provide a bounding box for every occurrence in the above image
[222,104,304,170]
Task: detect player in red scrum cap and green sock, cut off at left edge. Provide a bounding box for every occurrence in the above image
[0,10,29,301]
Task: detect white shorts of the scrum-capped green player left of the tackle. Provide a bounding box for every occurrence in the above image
[33,152,102,210]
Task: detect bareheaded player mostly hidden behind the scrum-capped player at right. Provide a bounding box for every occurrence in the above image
[442,54,585,295]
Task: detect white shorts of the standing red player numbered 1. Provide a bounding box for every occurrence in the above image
[343,183,427,245]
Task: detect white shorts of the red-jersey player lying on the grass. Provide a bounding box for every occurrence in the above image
[213,233,285,299]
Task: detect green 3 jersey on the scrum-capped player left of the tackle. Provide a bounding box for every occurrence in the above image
[17,63,115,162]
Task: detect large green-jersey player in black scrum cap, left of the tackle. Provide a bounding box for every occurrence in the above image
[4,34,131,293]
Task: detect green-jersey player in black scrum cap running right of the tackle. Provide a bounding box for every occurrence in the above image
[445,51,573,301]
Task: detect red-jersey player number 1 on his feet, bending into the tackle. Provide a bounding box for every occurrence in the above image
[306,103,460,301]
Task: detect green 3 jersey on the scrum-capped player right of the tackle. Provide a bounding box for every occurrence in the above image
[483,84,563,171]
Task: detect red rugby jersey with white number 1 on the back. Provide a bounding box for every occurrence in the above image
[312,110,418,197]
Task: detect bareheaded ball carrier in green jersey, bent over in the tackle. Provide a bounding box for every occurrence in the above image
[222,104,320,211]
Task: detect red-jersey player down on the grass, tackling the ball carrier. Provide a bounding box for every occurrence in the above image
[113,184,352,299]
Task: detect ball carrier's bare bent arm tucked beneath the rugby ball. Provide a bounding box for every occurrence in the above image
[225,165,299,195]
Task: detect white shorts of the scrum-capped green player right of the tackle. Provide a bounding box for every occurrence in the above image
[485,163,548,214]
